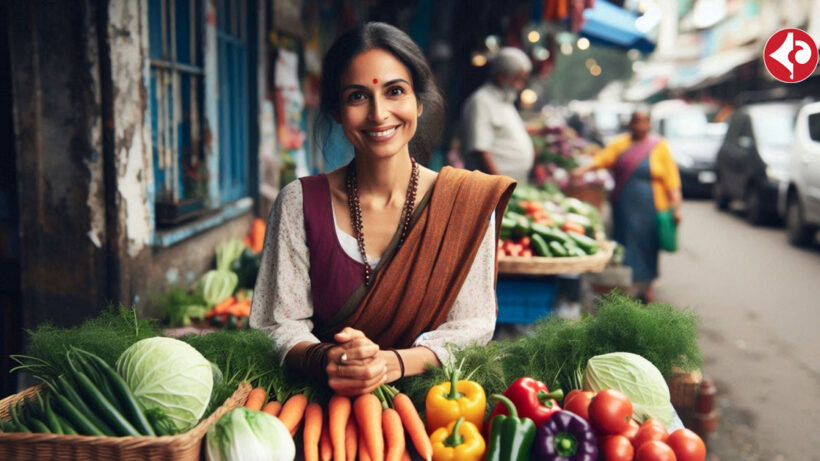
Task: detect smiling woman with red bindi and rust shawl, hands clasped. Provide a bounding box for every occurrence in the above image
[250,23,515,396]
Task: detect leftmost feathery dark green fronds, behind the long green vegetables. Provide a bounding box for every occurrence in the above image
[14,306,159,377]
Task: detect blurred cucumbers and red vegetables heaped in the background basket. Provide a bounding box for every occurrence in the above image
[498,185,603,258]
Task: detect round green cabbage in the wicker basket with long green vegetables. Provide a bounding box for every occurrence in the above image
[117,337,214,432]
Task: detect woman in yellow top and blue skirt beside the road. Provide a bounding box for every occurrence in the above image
[572,110,683,302]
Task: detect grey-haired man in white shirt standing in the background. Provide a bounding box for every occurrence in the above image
[462,47,535,182]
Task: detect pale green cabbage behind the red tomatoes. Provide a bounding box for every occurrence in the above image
[584,352,675,427]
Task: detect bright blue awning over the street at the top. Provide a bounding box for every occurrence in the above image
[578,0,655,54]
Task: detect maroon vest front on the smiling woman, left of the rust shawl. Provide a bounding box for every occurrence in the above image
[299,174,364,323]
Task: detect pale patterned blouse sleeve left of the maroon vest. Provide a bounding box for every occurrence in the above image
[250,181,319,364]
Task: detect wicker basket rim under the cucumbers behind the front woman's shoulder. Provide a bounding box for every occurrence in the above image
[498,241,615,275]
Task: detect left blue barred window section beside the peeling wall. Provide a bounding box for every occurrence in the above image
[148,0,208,226]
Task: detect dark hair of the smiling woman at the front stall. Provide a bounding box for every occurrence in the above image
[316,22,444,163]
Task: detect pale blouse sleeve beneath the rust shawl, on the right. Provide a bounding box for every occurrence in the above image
[413,214,498,364]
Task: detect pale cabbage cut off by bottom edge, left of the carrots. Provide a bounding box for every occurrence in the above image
[205,407,296,461]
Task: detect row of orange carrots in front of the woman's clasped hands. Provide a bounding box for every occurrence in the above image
[240,386,433,461]
